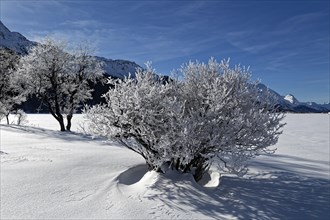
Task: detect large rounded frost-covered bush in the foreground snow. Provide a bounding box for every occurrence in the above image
[84,59,284,181]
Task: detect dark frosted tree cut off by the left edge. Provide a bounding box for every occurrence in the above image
[0,48,25,124]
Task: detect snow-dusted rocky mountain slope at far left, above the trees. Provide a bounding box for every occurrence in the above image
[0,21,36,55]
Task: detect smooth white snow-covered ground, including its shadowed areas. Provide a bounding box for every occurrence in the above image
[0,114,330,219]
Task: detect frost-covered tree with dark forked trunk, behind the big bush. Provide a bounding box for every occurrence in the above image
[16,39,103,131]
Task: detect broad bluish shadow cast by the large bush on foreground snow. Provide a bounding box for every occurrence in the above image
[144,155,330,219]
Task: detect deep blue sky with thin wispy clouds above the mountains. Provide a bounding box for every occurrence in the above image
[0,0,330,103]
